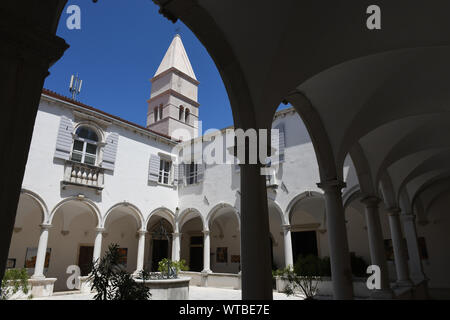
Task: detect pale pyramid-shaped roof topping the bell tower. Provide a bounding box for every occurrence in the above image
[154,34,197,80]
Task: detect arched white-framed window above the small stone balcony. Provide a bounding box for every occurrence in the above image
[71,126,98,165]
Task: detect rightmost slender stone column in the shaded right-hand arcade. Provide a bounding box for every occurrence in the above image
[401,213,427,284]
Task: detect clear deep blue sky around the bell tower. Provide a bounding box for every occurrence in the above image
[44,0,233,130]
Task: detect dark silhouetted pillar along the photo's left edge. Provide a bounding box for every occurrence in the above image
[0,0,68,279]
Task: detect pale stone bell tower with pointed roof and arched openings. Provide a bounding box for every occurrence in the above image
[147,34,200,141]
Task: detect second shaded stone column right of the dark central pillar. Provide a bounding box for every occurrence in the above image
[361,196,392,299]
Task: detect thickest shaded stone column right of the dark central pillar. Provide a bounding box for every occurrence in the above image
[317,180,353,300]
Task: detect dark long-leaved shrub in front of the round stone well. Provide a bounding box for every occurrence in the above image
[89,244,151,300]
